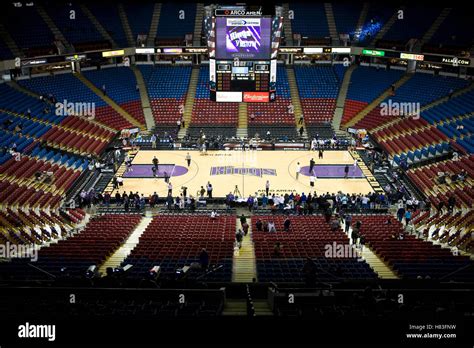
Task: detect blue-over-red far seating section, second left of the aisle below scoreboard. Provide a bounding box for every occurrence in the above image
[138,65,191,127]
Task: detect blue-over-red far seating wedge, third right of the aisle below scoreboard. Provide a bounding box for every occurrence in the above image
[342,66,403,124]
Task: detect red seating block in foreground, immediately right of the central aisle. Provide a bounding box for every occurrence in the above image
[251,215,376,282]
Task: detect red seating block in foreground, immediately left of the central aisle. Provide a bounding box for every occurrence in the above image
[123,214,236,281]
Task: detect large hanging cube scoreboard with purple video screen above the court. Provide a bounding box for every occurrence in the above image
[208,11,281,102]
